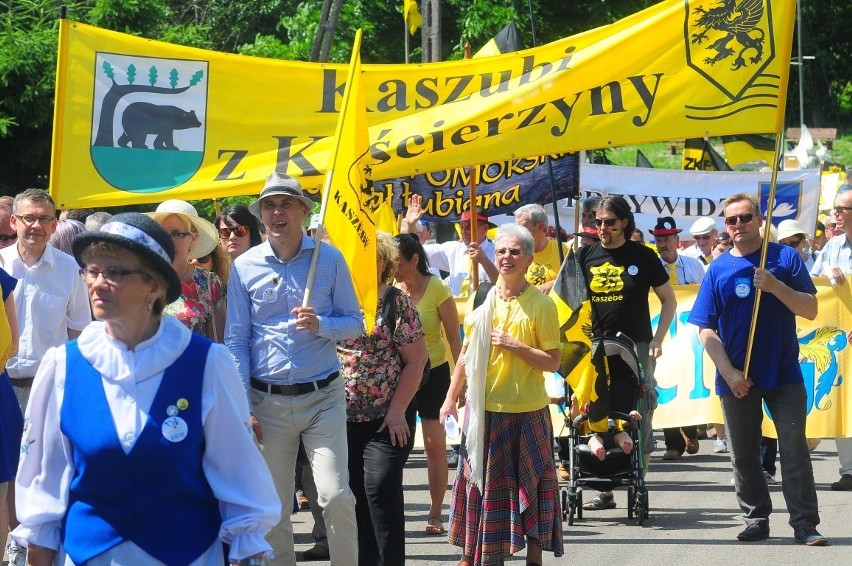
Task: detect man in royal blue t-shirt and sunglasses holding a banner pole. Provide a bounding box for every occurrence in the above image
[689,193,828,546]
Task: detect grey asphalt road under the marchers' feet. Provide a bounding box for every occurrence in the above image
[3,434,852,566]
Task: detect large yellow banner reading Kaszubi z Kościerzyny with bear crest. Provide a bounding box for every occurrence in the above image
[55,0,795,208]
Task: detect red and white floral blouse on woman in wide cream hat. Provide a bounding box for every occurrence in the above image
[163,267,225,340]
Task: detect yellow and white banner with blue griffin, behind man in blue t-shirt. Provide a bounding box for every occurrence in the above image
[651,277,852,438]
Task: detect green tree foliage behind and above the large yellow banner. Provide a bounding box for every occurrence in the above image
[0,0,852,193]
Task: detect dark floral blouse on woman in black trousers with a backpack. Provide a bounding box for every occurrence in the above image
[337,292,423,422]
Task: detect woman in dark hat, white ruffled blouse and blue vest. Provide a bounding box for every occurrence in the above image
[13,213,280,566]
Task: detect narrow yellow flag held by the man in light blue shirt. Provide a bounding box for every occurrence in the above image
[320,29,378,329]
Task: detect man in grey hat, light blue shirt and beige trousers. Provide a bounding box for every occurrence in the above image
[225,173,364,566]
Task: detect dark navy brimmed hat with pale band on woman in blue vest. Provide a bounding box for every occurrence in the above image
[71,212,181,303]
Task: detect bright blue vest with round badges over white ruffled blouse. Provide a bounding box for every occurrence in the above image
[60,334,222,565]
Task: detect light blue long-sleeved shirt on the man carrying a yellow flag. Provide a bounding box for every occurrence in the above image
[225,236,364,390]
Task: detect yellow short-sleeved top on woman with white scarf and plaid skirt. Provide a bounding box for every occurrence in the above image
[465,286,559,413]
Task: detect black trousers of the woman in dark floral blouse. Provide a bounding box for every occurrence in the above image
[346,404,416,566]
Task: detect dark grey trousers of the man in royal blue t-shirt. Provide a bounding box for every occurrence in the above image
[721,383,819,528]
